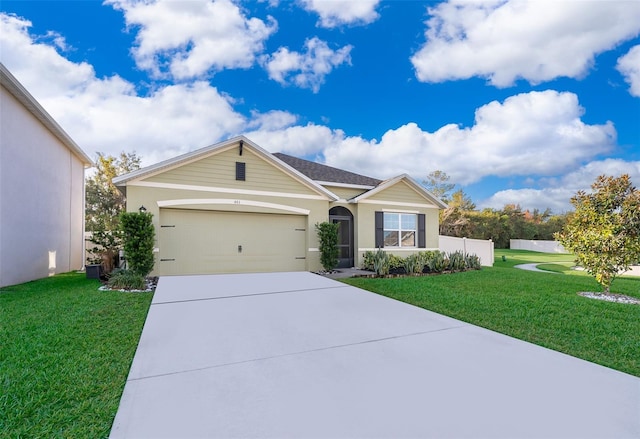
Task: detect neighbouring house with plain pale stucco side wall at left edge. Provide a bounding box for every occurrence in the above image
[0,64,92,287]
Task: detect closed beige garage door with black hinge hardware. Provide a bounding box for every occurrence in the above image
[156,208,307,275]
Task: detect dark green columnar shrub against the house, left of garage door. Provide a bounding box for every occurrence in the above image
[120,212,154,276]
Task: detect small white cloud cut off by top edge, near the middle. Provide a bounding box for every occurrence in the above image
[302,0,380,28]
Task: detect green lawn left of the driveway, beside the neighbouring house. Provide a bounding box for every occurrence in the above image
[0,273,152,438]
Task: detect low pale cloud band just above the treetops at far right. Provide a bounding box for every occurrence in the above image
[478,159,640,213]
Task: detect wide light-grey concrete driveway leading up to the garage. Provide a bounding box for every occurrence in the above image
[111,272,640,438]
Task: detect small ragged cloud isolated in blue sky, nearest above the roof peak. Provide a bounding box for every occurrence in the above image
[262,37,353,93]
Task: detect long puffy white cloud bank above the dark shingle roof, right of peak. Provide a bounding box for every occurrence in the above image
[324,90,616,185]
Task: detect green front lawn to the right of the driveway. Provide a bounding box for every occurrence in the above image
[344,250,640,376]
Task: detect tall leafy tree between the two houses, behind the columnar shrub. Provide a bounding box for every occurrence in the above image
[85,152,141,274]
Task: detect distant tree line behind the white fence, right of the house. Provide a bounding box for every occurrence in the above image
[423,171,570,248]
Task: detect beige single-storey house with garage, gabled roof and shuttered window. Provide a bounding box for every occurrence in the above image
[114,136,446,275]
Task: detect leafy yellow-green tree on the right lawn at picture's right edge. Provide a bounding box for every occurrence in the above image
[556,174,640,293]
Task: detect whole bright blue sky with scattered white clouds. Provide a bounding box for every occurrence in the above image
[0,0,640,213]
